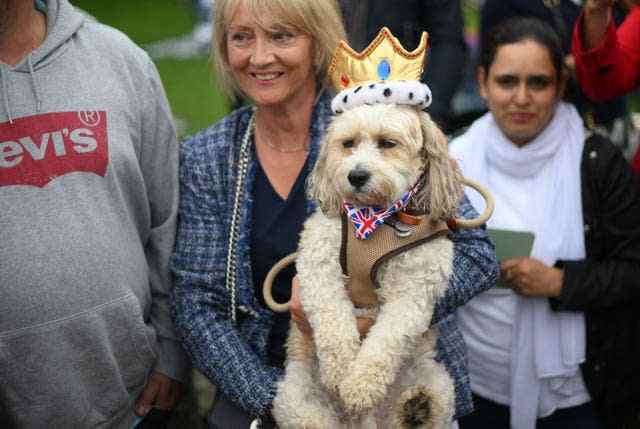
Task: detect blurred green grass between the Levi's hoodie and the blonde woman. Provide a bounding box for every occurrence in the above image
[71,0,229,137]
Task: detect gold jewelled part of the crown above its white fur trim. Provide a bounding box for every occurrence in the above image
[329,27,429,92]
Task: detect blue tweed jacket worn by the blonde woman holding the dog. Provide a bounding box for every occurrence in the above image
[171,96,498,416]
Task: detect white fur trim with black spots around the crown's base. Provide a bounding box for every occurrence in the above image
[331,80,431,114]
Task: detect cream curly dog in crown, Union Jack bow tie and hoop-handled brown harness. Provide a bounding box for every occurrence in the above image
[264,28,493,429]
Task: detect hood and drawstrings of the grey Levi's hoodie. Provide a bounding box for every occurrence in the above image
[0,0,85,123]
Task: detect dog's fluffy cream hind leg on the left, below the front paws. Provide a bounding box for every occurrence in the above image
[272,322,340,429]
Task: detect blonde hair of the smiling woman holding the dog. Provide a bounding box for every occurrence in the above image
[211,0,346,100]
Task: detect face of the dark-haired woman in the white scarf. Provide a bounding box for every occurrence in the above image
[478,40,564,146]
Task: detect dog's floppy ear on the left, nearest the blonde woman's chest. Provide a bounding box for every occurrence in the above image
[307,126,342,216]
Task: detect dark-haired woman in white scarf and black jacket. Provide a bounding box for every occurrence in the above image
[451,18,640,429]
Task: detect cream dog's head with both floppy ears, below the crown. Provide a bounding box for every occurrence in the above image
[309,104,461,217]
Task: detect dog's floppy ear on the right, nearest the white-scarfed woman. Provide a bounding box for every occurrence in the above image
[418,112,463,219]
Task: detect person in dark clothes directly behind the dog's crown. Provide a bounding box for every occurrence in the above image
[340,0,467,133]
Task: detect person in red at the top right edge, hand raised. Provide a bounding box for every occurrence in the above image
[572,0,640,175]
